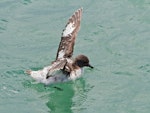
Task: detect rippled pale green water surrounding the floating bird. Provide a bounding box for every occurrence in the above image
[0,0,150,113]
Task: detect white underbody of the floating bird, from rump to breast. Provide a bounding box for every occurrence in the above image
[30,66,82,85]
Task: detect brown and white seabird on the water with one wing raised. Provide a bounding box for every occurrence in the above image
[25,8,94,85]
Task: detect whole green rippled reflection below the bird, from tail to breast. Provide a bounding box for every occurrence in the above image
[23,78,90,113]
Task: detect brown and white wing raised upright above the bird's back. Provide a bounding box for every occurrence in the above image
[56,8,82,60]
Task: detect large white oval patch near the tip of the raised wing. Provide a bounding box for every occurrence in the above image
[63,23,75,37]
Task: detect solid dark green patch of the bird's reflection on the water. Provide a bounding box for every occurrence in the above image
[46,84,74,113]
